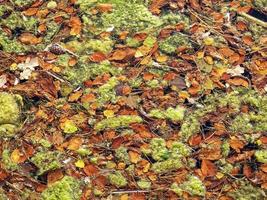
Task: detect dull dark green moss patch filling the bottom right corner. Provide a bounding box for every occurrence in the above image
[228,181,267,200]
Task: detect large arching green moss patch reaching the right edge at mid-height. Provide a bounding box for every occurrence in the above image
[180,88,267,139]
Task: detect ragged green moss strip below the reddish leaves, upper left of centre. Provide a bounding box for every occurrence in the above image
[63,57,122,86]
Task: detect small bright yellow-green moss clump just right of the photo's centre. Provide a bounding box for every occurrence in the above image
[149,106,185,121]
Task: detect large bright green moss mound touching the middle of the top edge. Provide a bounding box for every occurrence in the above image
[101,1,162,32]
